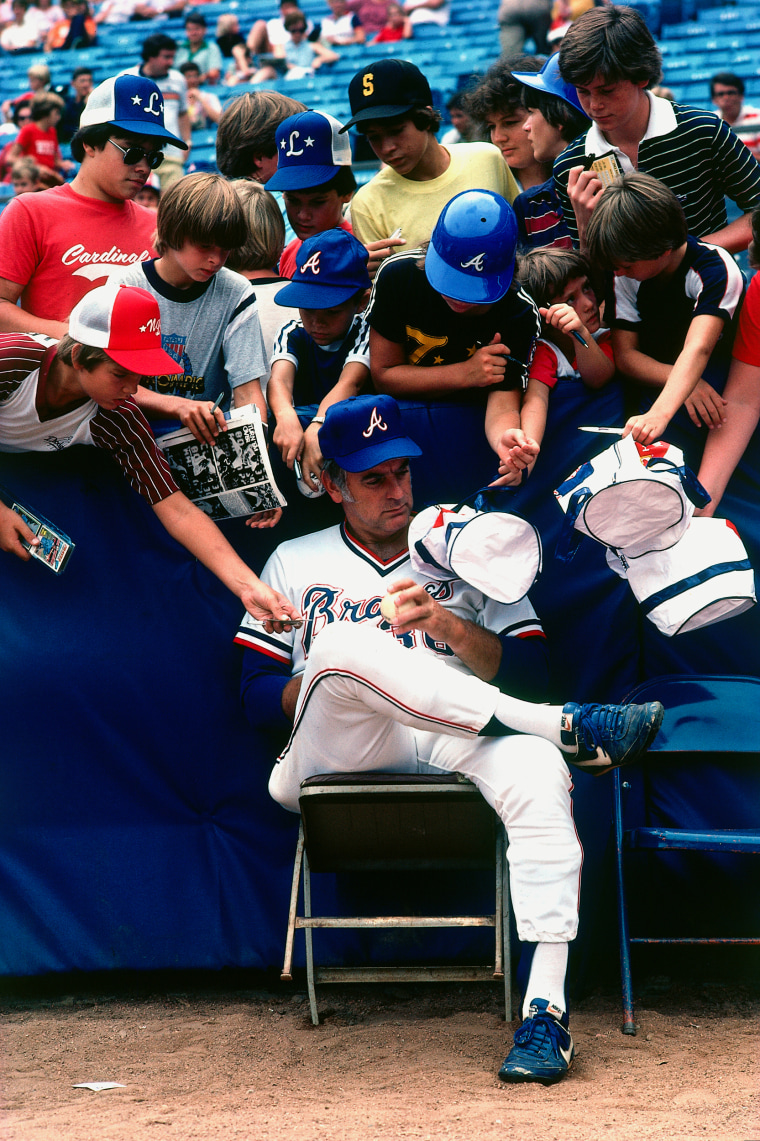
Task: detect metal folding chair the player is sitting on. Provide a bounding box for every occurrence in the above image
[282,772,512,1026]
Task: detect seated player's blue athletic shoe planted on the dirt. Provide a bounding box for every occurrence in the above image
[499,998,575,1085]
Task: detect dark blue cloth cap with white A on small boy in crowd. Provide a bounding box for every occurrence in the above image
[275,229,371,309]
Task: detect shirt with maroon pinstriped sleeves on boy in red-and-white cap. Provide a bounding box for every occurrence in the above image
[0,333,177,504]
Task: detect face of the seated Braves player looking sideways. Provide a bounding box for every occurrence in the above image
[331,460,412,543]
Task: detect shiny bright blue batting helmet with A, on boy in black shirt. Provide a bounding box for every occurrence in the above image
[425,191,517,305]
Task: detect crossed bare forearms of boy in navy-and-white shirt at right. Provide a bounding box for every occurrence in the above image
[613,314,726,444]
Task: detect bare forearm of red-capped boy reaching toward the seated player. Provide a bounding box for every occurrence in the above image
[153,492,299,632]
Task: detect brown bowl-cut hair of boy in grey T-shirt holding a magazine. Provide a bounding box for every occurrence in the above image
[155,173,248,256]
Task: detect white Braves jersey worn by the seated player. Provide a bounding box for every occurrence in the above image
[235,524,543,674]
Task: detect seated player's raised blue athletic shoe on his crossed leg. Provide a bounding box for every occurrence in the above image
[560,702,664,776]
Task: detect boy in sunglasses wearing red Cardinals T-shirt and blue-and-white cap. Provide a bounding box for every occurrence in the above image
[0,75,185,338]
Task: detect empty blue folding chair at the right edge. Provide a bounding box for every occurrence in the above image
[613,674,760,1034]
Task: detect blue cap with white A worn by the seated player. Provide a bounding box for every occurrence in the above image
[317,395,422,471]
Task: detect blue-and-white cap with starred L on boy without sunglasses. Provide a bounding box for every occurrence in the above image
[267,111,351,191]
